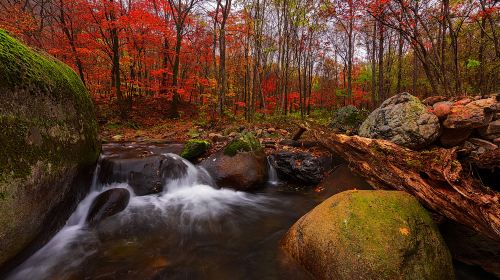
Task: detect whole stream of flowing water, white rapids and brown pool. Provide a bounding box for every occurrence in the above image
[7,144,372,280]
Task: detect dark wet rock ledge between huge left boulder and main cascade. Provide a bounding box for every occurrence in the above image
[99,155,187,195]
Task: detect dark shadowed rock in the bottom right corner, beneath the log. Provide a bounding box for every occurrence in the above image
[440,221,500,277]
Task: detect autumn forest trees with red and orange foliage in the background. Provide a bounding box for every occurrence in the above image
[0,0,500,119]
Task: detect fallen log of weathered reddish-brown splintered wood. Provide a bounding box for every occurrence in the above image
[312,130,500,240]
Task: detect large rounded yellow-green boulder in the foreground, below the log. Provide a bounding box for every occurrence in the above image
[282,191,454,280]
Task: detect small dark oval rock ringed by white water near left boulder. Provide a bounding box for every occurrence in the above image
[86,188,130,227]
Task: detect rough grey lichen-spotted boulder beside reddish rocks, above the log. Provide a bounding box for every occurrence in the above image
[359,93,440,149]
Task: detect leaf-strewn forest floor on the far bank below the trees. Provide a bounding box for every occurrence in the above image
[94,98,329,158]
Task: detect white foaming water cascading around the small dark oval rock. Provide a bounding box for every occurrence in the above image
[7,154,272,280]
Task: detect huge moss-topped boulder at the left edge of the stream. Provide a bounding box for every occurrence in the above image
[0,30,100,267]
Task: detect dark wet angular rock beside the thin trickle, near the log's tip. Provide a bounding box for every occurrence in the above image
[270,152,324,185]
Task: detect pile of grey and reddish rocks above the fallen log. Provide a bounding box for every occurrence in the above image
[359,93,500,160]
